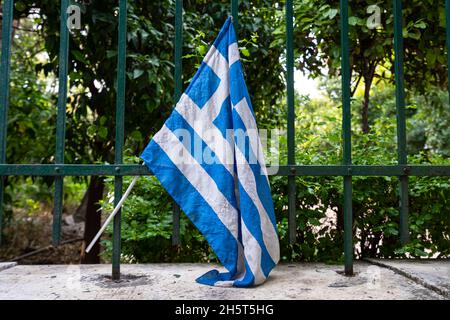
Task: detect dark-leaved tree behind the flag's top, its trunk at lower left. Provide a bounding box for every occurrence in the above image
[15,0,284,262]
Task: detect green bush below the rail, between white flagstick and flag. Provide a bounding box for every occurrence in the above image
[102,158,215,263]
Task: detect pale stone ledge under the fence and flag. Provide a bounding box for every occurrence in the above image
[0,260,450,300]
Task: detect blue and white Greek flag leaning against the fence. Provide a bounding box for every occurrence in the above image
[141,18,280,287]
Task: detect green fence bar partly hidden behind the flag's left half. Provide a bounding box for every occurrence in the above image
[172,0,183,246]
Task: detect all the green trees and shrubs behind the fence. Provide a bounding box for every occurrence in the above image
[0,0,450,262]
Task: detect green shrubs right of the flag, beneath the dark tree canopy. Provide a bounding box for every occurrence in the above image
[278,79,450,261]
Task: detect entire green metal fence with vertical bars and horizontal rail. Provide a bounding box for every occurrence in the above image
[0,0,450,279]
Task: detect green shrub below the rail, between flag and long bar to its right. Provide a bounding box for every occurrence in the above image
[270,177,343,262]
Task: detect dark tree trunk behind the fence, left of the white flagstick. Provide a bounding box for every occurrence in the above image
[81,176,105,264]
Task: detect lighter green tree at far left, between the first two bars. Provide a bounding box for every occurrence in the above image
[4,14,56,225]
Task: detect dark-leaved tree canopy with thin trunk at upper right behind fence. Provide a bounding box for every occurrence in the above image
[286,0,447,133]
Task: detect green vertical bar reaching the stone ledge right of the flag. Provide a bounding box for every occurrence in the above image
[340,0,353,275]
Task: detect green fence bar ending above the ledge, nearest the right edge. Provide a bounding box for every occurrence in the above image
[394,0,409,244]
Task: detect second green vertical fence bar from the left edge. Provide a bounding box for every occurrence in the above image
[52,0,69,246]
